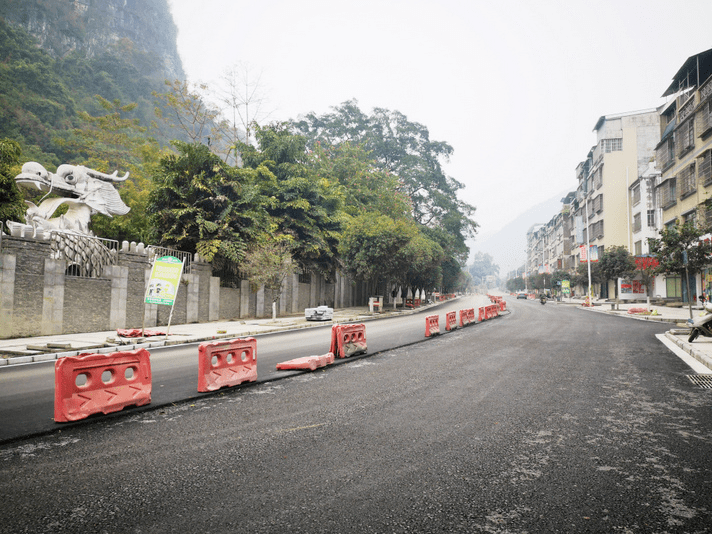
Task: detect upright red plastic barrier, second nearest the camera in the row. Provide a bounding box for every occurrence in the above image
[198,337,257,393]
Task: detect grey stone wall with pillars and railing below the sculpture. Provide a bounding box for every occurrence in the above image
[0,234,367,338]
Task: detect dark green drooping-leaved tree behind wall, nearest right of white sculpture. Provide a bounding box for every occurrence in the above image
[148,141,275,272]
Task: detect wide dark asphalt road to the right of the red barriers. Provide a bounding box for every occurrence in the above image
[0,300,712,533]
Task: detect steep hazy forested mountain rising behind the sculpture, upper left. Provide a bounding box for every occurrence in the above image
[0,0,184,167]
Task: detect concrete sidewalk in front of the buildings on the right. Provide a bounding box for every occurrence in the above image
[556,299,712,373]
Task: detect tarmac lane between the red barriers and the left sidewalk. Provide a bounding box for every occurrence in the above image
[0,296,483,442]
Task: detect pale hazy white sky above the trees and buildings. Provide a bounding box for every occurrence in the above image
[169,0,712,274]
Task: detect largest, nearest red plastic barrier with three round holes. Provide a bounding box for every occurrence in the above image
[54,349,151,423]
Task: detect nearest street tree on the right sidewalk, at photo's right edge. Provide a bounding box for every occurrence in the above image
[648,222,712,318]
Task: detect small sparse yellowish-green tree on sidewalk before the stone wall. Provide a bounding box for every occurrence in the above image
[240,234,297,320]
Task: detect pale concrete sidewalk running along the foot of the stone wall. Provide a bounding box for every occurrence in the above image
[0,297,456,366]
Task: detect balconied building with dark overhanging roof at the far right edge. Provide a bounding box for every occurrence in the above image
[656,49,712,300]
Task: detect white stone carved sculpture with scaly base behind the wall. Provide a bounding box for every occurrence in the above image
[7,161,131,277]
